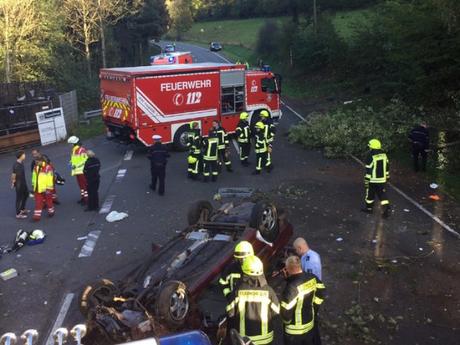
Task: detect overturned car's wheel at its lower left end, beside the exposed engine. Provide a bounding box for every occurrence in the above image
[80,279,118,317]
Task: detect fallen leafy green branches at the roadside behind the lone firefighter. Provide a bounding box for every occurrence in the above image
[289,100,418,157]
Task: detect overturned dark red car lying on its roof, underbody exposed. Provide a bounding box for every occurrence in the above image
[80,192,293,344]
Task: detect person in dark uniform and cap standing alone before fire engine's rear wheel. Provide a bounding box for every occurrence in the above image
[147,134,169,195]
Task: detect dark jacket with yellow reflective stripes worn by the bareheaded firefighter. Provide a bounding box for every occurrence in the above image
[281,272,325,335]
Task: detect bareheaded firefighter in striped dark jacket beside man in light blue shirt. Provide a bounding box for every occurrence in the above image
[281,256,325,345]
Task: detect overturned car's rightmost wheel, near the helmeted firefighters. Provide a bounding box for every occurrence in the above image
[249,202,279,242]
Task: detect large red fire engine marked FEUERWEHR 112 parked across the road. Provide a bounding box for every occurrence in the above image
[100,62,281,150]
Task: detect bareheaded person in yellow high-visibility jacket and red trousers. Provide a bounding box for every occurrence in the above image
[32,157,54,221]
